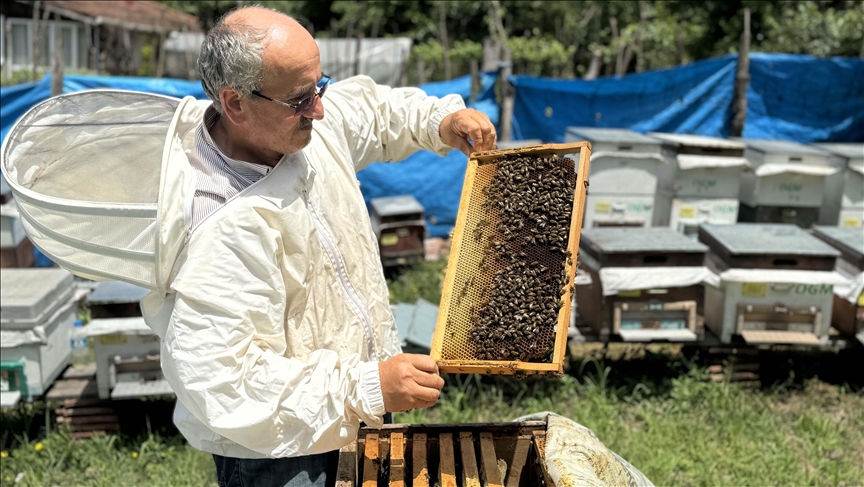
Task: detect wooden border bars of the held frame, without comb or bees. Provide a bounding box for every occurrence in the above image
[431,142,591,375]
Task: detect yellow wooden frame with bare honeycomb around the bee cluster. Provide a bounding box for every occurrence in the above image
[431,142,591,375]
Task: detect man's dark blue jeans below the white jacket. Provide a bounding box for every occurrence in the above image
[213,413,393,487]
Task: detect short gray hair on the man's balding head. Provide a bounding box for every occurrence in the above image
[198,5,286,114]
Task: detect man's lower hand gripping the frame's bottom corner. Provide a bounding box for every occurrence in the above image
[378,353,444,413]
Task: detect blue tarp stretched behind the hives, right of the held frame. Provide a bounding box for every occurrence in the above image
[511,53,864,143]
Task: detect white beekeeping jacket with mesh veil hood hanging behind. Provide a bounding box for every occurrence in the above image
[2,77,464,458]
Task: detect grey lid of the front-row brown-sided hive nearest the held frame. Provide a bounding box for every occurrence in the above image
[580,228,708,254]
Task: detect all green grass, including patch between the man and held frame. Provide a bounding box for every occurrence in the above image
[0,263,864,487]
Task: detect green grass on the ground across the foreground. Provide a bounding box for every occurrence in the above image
[0,370,864,486]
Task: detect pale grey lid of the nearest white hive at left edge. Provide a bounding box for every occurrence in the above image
[0,268,74,326]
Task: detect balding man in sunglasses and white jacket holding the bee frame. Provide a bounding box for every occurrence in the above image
[143,7,495,486]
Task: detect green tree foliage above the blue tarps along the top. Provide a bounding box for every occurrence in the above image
[161,0,864,80]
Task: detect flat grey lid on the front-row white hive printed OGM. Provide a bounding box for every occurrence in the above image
[699,223,840,257]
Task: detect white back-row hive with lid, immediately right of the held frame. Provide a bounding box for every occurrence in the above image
[564,127,670,228]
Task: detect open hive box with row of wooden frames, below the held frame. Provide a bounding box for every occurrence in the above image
[336,422,552,487]
